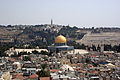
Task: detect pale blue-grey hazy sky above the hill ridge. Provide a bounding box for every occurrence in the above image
[0,0,120,27]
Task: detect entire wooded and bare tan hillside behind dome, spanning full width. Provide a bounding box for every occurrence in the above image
[0,24,120,47]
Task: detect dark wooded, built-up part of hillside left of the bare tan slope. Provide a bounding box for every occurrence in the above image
[0,24,85,46]
